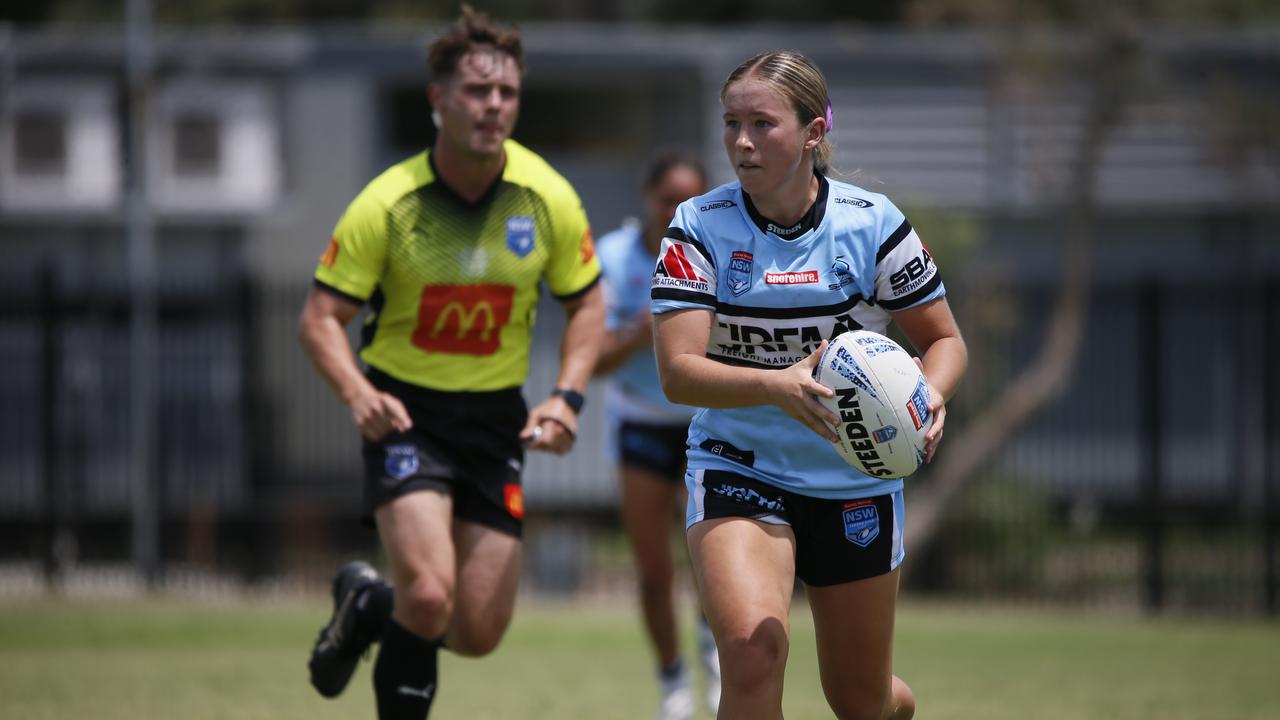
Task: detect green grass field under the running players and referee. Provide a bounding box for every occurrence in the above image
[0,598,1280,720]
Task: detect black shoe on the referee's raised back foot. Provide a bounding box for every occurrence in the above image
[307,560,380,697]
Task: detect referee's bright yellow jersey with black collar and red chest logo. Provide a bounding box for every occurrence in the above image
[315,140,600,391]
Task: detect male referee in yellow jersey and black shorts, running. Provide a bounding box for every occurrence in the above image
[300,5,604,720]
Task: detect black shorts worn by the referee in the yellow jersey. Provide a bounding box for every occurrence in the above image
[364,368,529,537]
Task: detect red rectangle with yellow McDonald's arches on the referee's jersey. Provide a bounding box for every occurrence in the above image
[413,284,516,355]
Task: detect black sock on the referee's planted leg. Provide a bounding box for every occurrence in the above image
[374,620,440,720]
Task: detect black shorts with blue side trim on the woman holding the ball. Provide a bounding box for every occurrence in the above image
[685,469,905,587]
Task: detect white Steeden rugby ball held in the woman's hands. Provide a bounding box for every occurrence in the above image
[813,331,933,478]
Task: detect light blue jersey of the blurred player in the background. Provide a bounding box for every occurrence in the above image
[595,220,694,425]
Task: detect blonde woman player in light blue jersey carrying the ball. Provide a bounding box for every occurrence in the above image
[653,51,968,720]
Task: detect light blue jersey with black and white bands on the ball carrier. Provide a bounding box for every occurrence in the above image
[650,178,946,498]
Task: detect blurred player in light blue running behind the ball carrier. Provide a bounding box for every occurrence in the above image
[596,152,719,720]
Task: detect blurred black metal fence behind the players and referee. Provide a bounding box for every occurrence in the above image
[0,257,1280,614]
